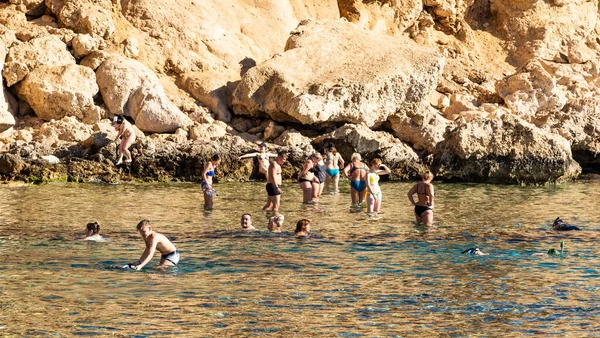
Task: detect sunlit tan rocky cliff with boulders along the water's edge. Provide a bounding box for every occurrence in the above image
[0,0,600,183]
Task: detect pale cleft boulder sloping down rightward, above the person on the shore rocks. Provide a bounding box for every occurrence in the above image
[96,55,193,133]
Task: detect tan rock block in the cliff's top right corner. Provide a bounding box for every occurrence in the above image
[490,0,598,66]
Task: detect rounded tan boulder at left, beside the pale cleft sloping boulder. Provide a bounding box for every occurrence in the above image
[18,65,98,121]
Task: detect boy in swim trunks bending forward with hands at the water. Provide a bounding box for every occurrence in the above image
[130,219,179,270]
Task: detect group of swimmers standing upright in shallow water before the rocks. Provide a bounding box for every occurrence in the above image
[201,143,435,227]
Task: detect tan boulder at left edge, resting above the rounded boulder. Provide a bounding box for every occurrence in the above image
[2,35,75,87]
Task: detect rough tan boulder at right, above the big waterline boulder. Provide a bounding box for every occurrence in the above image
[496,61,567,116]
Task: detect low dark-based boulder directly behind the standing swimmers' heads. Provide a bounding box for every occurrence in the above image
[313,124,424,179]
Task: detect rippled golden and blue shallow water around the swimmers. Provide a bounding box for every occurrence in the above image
[0,182,600,337]
